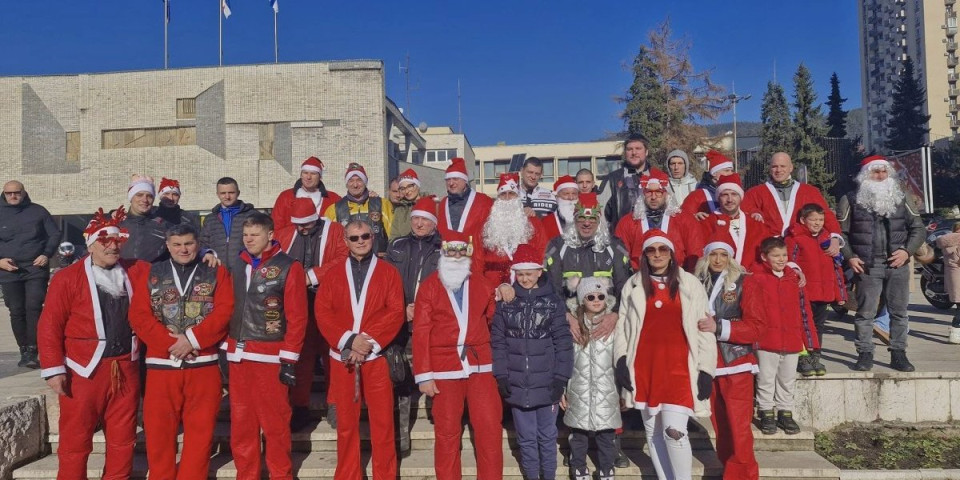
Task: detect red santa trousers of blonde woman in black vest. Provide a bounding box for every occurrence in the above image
[710,372,760,480]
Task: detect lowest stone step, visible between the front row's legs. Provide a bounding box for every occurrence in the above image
[13,450,840,480]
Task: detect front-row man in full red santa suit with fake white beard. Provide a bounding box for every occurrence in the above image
[413,232,503,480]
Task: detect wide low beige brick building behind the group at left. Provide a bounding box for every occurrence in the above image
[0,60,428,214]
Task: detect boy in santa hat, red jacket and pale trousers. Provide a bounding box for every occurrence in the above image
[741,237,820,435]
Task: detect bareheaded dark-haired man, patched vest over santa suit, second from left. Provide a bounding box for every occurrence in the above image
[130,223,233,479]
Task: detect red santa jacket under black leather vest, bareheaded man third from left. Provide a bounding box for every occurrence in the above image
[220,241,307,363]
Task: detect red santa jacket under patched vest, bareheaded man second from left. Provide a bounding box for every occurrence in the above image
[130,262,233,368]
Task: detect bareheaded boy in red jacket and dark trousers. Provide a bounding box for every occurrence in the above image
[784,203,847,377]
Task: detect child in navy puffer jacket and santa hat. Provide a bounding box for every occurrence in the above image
[490,244,573,480]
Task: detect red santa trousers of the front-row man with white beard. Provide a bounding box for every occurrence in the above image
[433,373,503,480]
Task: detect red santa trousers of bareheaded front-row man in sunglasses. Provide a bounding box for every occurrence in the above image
[330,357,397,480]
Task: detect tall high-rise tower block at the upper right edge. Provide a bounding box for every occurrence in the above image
[858,0,960,151]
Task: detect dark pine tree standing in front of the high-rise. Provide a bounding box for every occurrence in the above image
[886,57,930,151]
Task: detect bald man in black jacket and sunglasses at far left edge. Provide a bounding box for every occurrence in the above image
[0,180,60,368]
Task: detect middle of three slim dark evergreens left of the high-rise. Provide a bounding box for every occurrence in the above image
[793,63,836,202]
